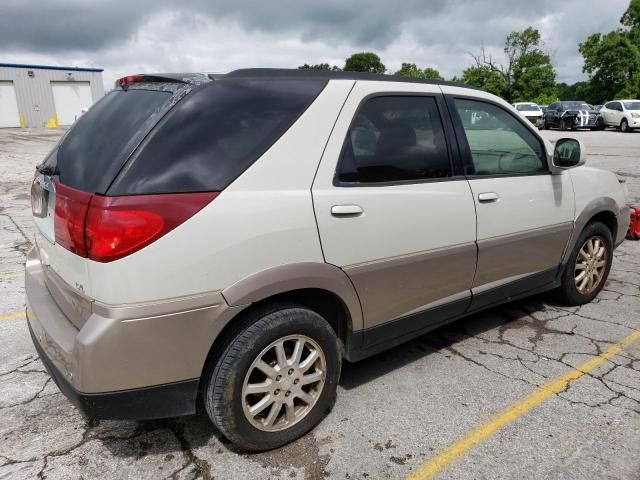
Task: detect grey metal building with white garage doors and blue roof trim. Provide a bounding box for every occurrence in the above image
[0,63,104,128]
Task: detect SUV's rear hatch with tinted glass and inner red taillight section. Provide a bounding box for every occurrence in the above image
[31,76,194,326]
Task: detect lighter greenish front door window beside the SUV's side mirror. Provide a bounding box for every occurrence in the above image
[455,99,547,175]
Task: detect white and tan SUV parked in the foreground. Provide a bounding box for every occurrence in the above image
[26,69,629,450]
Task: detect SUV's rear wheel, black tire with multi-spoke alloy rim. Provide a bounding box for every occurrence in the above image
[203,304,341,452]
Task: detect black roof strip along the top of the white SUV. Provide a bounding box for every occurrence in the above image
[220,68,478,90]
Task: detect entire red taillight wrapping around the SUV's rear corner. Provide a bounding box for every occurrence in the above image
[54,184,218,262]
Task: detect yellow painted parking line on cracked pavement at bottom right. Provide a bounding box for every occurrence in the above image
[407,330,640,480]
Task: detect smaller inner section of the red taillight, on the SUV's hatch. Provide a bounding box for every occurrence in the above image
[53,183,92,257]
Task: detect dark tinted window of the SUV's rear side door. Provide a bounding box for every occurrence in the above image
[337,96,451,183]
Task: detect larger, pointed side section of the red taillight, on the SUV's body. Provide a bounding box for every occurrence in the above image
[85,192,218,262]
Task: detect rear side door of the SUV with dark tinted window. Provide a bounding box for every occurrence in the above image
[312,81,476,346]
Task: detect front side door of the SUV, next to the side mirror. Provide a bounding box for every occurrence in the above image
[443,91,574,309]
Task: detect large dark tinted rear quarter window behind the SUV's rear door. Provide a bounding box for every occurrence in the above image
[109,79,326,195]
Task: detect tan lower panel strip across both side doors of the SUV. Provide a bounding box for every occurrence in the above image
[344,222,573,328]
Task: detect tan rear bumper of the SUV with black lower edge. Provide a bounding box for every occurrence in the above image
[25,247,242,419]
